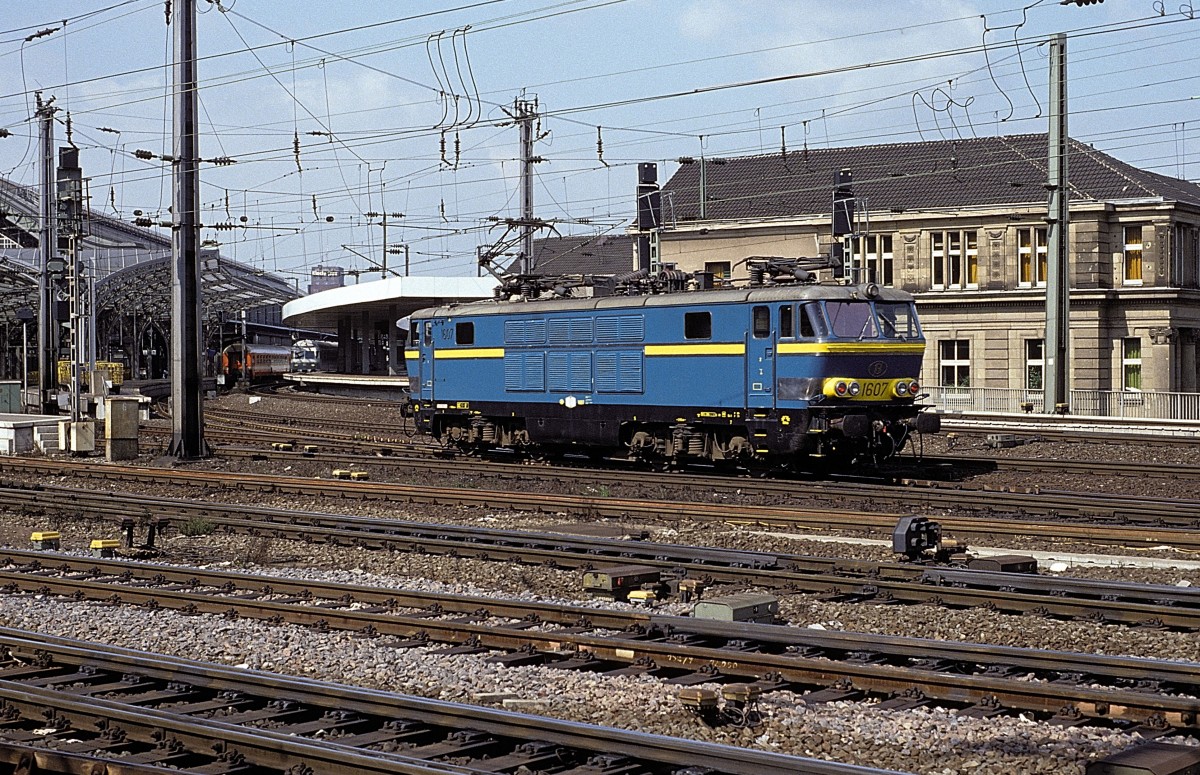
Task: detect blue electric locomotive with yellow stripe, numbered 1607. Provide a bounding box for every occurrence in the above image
[404,283,940,467]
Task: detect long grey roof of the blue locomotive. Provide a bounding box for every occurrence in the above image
[412,284,912,319]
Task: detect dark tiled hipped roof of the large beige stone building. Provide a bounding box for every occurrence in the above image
[664,134,1200,222]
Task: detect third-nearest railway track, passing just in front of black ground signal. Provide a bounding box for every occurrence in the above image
[7,486,1200,631]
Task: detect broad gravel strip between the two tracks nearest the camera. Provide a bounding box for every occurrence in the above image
[0,595,1200,775]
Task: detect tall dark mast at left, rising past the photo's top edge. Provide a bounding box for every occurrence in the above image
[168,0,209,459]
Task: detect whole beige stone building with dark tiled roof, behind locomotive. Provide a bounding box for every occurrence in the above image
[659,134,1200,403]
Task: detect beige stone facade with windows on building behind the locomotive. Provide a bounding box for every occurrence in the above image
[660,133,1200,392]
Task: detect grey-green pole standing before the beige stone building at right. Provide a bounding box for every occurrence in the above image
[1043,32,1070,414]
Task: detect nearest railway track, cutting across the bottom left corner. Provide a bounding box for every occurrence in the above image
[0,629,884,775]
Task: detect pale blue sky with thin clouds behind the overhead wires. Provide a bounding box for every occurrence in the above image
[0,0,1200,288]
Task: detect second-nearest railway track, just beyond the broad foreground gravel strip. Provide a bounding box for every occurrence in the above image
[0,551,1200,734]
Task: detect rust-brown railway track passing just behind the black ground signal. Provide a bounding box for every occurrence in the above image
[0,458,1200,549]
